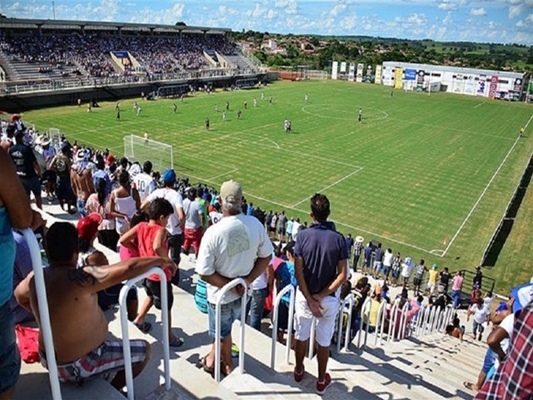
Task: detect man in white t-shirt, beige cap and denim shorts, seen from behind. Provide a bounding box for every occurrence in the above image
[196,181,274,374]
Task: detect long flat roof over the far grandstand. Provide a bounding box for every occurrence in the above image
[0,18,231,33]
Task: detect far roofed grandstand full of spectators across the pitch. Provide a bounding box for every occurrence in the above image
[0,18,265,111]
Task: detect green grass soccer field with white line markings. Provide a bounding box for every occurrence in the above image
[24,81,533,294]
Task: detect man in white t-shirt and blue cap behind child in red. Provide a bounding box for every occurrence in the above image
[141,168,185,286]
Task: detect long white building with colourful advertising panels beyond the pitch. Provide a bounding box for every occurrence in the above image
[376,61,527,100]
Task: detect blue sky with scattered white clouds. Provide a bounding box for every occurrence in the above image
[0,0,533,46]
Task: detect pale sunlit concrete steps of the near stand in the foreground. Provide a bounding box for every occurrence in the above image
[14,201,486,400]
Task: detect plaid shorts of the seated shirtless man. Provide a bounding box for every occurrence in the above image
[39,340,148,383]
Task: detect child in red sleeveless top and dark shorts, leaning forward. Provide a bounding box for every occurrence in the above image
[120,198,183,347]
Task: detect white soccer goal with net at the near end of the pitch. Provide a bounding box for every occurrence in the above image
[124,135,174,173]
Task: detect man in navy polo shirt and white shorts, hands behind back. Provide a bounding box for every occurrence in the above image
[294,193,348,394]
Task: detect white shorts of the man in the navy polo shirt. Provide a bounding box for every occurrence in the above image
[294,290,339,347]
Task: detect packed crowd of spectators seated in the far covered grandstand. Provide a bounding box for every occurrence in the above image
[0,30,240,78]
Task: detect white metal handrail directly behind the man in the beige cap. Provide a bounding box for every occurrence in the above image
[215,278,248,382]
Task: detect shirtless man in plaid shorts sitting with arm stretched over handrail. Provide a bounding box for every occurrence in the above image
[15,222,176,389]
